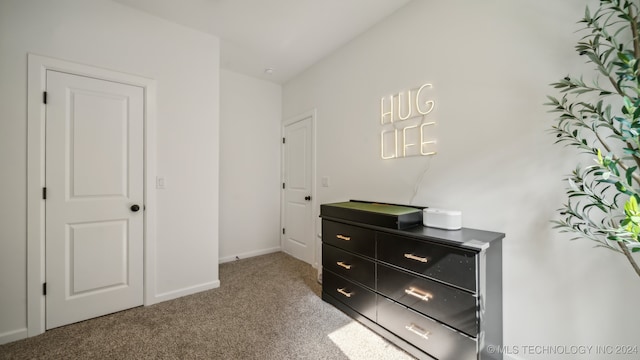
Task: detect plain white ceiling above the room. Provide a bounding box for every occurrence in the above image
[113,0,410,83]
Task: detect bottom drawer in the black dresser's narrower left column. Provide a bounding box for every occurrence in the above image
[322,271,376,321]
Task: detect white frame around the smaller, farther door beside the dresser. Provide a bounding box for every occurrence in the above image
[280,109,320,269]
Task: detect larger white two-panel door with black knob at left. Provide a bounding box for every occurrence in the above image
[45,70,144,329]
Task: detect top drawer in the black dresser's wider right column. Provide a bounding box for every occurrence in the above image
[377,232,477,292]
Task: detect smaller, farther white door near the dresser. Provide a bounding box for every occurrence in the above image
[282,117,314,264]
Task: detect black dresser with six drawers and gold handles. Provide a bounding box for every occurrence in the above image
[321,205,504,360]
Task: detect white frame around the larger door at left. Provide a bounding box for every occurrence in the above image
[27,53,157,336]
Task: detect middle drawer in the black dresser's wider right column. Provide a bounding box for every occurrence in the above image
[376,265,478,337]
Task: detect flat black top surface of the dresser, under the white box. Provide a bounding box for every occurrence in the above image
[322,216,505,251]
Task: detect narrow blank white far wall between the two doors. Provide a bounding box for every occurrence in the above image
[220,70,282,262]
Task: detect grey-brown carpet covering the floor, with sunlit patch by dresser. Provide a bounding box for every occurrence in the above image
[0,253,413,360]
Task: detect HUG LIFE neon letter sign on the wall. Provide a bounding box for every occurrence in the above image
[380,84,436,160]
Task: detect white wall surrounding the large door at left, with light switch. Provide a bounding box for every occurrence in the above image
[0,0,219,343]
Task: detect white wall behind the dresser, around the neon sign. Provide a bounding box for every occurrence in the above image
[283,0,640,359]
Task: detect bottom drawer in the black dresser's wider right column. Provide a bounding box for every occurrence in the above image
[378,296,477,360]
